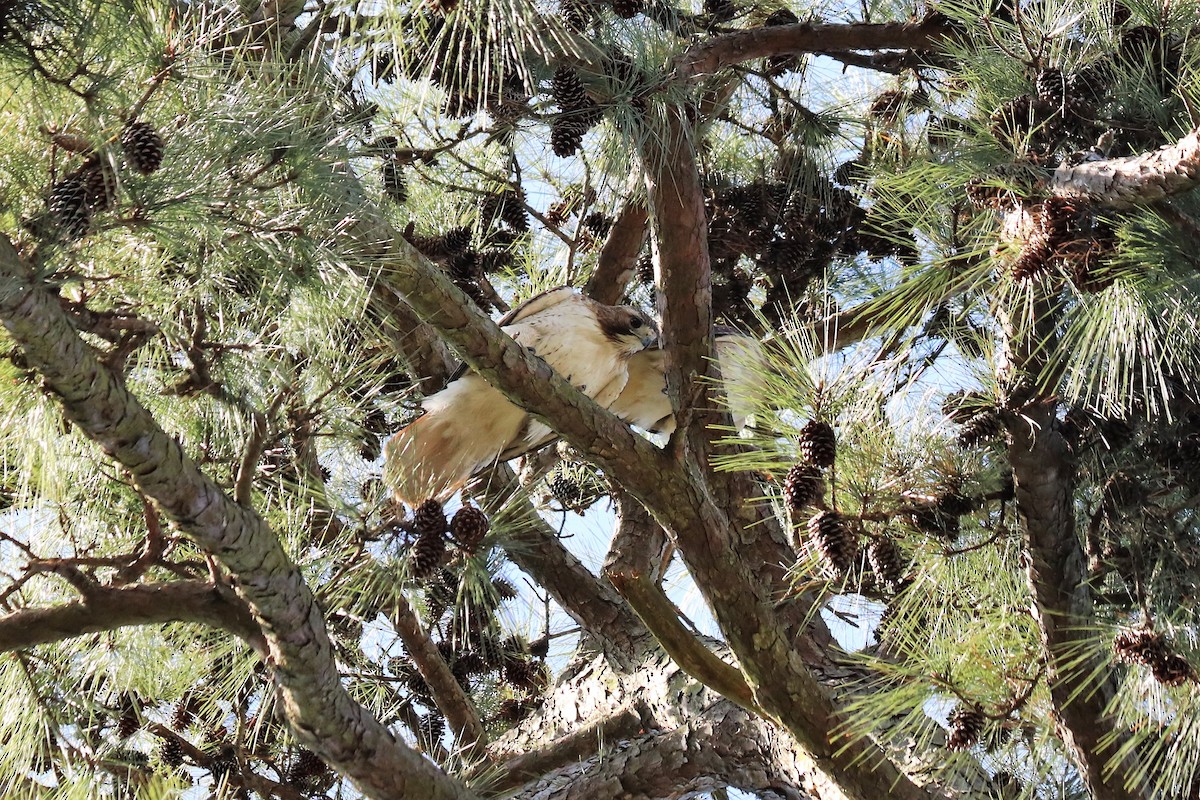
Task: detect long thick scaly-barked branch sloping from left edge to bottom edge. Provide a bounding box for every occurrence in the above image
[0,237,469,800]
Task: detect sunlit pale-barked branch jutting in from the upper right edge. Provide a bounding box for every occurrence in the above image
[1049,123,1200,209]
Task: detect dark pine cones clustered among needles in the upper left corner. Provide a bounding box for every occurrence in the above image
[46,121,163,240]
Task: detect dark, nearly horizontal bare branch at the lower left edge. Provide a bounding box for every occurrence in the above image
[0,581,265,652]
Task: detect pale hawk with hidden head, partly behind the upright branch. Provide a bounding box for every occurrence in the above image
[608,325,766,433]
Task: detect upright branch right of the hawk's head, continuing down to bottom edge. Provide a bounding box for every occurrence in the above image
[626,108,929,800]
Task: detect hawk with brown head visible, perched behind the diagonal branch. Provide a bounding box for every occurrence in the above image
[384,287,658,506]
